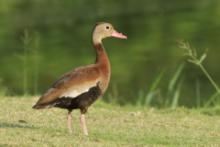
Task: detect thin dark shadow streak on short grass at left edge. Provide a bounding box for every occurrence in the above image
[0,122,38,129]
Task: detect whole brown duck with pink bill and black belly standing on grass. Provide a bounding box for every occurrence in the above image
[33,23,127,135]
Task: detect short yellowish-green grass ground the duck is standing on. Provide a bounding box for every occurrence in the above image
[0,97,220,147]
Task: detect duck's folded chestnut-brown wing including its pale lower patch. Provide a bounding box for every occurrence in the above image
[33,66,101,109]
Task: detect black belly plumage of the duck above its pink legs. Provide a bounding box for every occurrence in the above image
[52,85,101,113]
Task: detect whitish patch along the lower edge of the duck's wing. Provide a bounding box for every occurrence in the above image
[59,82,97,99]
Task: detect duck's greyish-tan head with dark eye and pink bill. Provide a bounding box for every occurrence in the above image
[93,22,127,44]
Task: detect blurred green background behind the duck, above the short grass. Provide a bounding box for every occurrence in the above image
[0,0,220,107]
